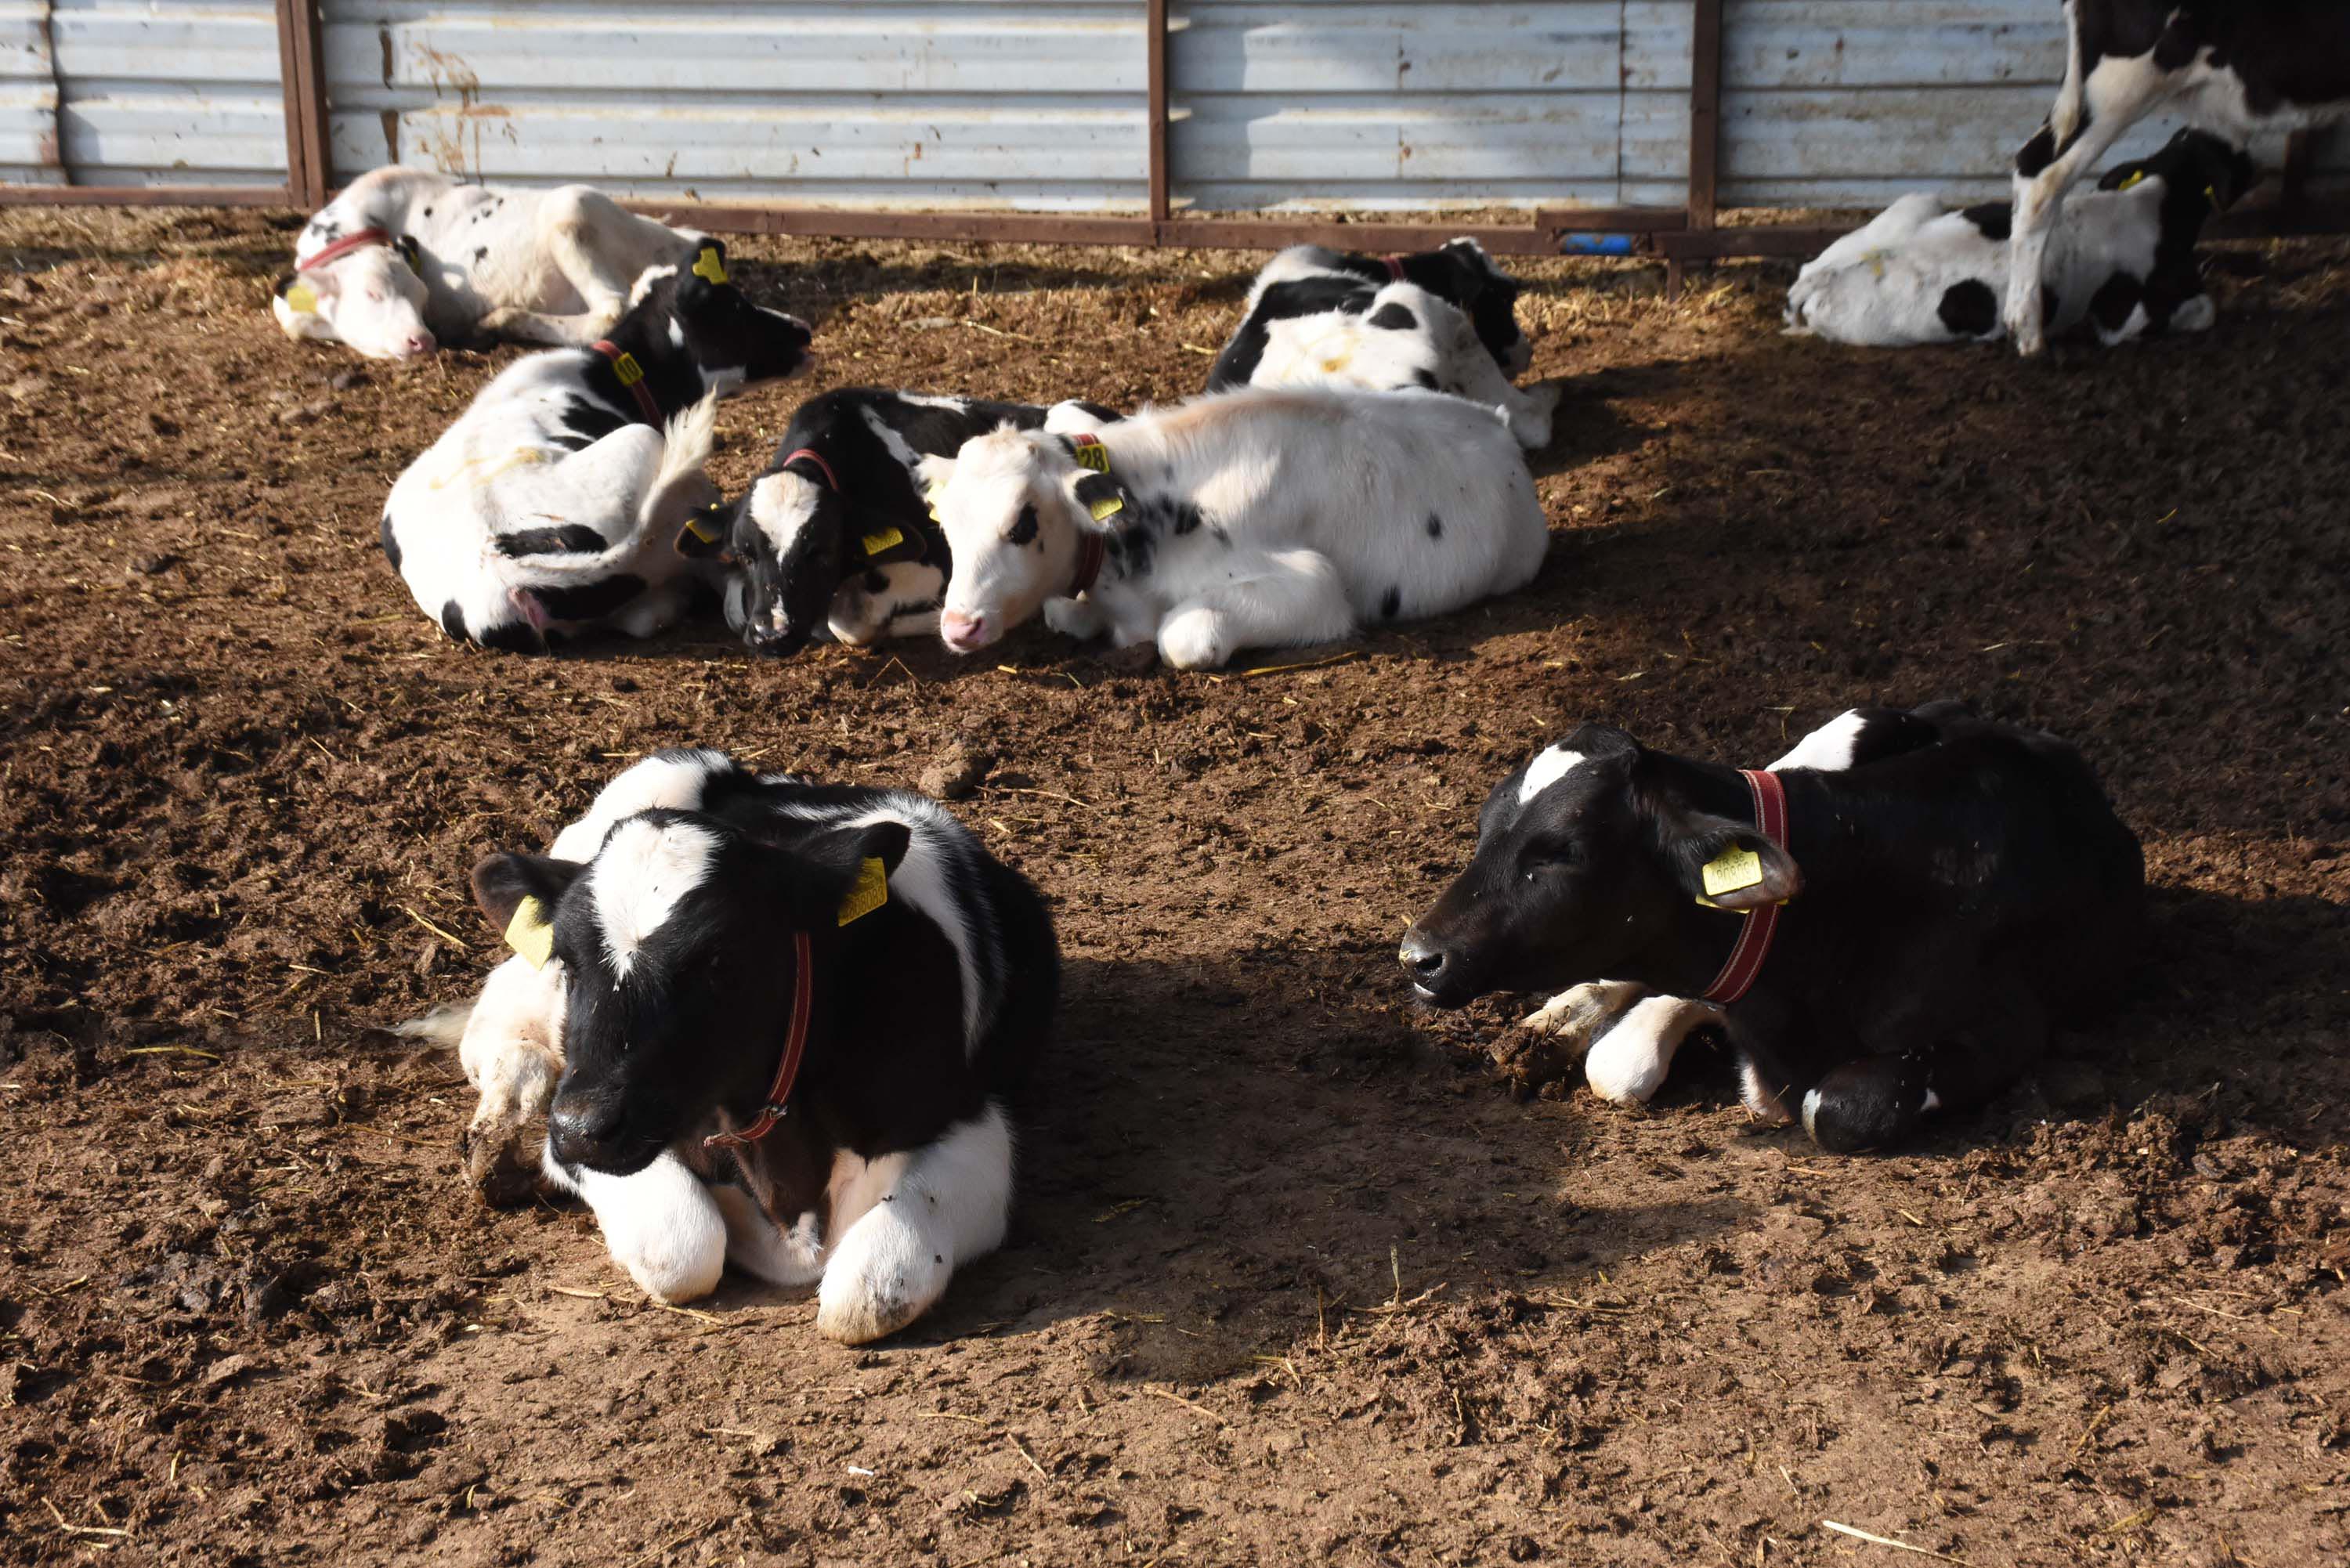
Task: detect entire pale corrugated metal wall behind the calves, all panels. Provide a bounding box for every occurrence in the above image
[0,0,2350,211]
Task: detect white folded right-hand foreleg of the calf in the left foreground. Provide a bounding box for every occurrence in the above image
[815,1100,1013,1345]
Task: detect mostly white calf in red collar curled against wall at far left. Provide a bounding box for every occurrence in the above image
[270,164,700,359]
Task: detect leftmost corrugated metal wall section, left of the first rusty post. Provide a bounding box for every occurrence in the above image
[0,0,287,186]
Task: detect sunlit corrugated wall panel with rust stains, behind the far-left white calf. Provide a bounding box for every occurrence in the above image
[324,0,1147,211]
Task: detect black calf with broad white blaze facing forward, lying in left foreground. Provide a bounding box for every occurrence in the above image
[411,752,1060,1342]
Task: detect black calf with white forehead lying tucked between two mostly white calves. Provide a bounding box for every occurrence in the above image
[677,385,1116,653]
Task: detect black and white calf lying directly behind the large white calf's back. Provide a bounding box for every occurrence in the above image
[1208,240,1558,449]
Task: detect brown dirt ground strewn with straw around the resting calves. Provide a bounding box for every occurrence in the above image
[0,211,2350,1568]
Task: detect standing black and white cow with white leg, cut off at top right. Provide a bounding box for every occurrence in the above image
[2007,0,2350,355]
